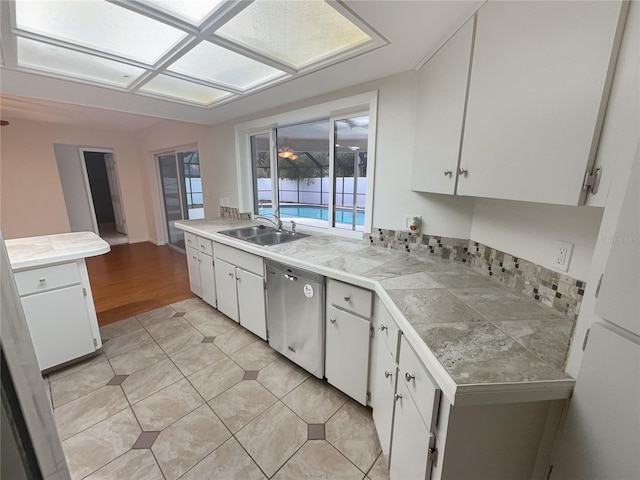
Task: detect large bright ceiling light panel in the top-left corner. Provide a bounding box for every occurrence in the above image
[16,0,185,64]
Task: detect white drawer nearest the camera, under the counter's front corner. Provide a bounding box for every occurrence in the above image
[399,335,440,432]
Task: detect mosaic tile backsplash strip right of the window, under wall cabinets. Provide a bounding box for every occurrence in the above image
[364,228,586,320]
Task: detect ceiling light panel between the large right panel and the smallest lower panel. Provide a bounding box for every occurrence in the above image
[168,42,285,90]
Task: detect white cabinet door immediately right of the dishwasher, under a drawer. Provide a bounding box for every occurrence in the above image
[325,306,370,405]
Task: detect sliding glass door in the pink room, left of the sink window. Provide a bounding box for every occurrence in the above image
[156,150,204,250]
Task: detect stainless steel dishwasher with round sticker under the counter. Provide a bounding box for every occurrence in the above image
[266,260,325,378]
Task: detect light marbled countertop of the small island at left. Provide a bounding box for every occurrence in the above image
[5,232,111,271]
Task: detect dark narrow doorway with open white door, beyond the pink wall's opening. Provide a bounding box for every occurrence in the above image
[81,149,129,245]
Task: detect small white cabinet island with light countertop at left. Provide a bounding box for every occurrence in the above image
[5,232,110,371]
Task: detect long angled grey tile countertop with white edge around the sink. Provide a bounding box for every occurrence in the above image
[176,219,574,403]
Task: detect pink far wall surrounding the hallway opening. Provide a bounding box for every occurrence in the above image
[0,120,149,242]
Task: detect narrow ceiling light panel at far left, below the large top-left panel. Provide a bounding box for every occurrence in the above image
[17,37,144,88]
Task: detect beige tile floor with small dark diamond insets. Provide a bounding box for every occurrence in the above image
[44,298,388,480]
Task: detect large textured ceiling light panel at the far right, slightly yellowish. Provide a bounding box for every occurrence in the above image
[216,0,371,68]
